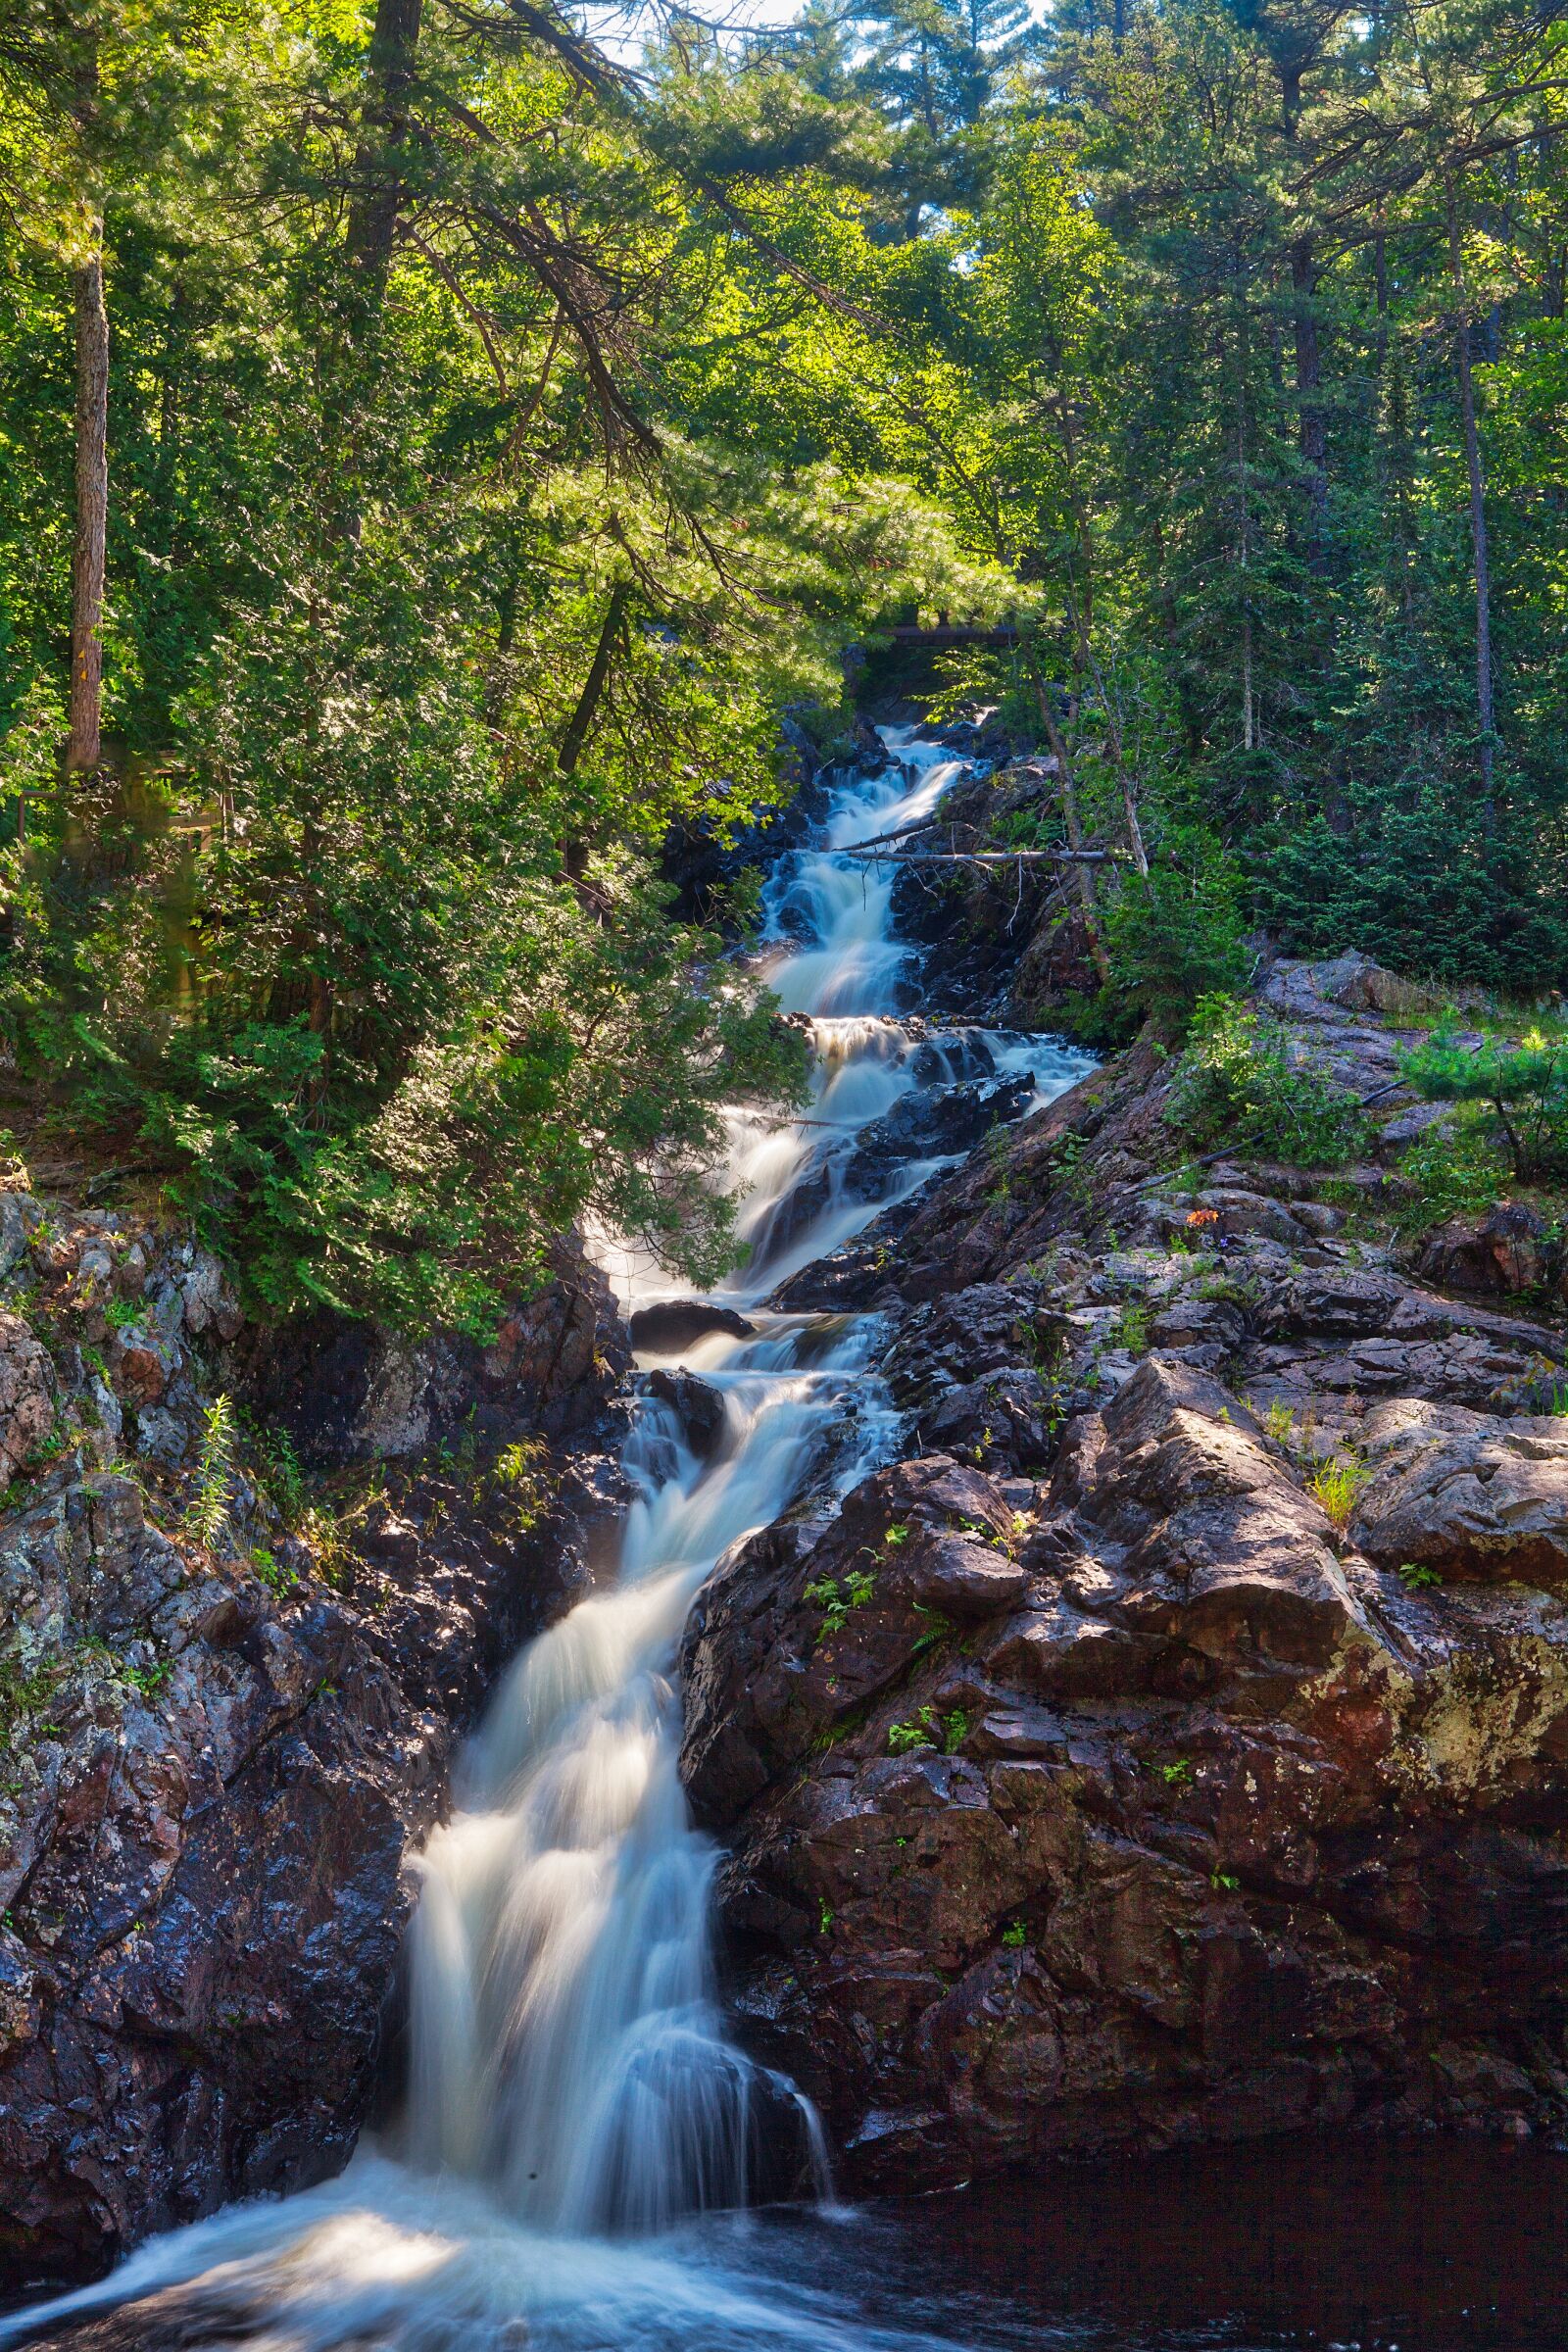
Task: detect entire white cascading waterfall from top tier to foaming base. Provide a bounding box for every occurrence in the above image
[0,736,1084,2352]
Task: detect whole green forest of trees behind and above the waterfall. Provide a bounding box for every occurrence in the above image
[0,0,1568,1331]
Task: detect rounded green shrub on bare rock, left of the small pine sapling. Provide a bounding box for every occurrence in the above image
[1166,998,1368,1166]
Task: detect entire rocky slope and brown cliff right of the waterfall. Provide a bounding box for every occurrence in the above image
[684,959,1568,2187]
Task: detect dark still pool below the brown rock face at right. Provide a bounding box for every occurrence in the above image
[719,2138,1568,2352]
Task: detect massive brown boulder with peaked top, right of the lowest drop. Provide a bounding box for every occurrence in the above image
[684,1354,1568,2187]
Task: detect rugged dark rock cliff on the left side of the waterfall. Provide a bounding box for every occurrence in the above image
[0,1193,625,2281]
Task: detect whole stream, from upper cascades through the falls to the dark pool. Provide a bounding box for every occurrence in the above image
[0,731,1563,2352]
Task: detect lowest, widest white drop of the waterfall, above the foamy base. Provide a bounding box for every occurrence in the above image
[394,1345,891,2232]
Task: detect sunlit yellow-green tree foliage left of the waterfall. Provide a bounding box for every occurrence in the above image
[0,0,1006,1336]
